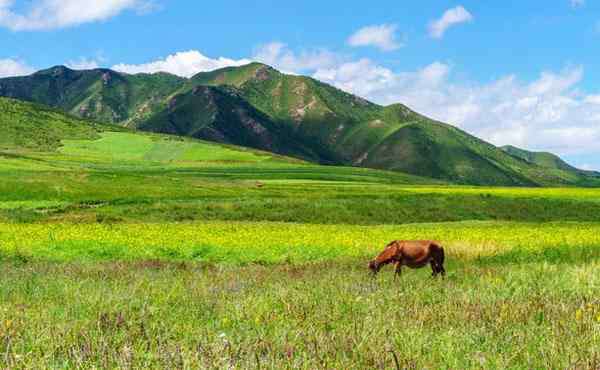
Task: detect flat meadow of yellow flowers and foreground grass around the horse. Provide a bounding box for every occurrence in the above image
[0,223,600,369]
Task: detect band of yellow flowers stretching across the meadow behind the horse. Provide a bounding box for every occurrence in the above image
[0,222,600,263]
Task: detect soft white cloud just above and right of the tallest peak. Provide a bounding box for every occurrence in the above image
[252,42,340,73]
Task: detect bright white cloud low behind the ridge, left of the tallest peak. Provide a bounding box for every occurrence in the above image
[112,50,251,77]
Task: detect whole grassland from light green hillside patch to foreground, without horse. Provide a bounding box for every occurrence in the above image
[0,132,600,369]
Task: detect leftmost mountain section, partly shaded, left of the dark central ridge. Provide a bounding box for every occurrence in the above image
[0,66,186,126]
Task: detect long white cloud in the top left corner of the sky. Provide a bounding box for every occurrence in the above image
[0,0,154,31]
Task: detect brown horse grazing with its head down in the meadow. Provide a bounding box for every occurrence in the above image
[369,240,446,279]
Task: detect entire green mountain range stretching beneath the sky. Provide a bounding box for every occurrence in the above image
[0,63,596,186]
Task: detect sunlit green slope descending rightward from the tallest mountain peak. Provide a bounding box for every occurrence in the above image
[191,63,596,185]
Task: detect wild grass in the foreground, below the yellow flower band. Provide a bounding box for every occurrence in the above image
[0,258,600,369]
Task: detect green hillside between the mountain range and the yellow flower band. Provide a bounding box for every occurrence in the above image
[0,94,600,224]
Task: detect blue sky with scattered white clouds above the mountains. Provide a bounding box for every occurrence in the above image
[0,0,600,169]
